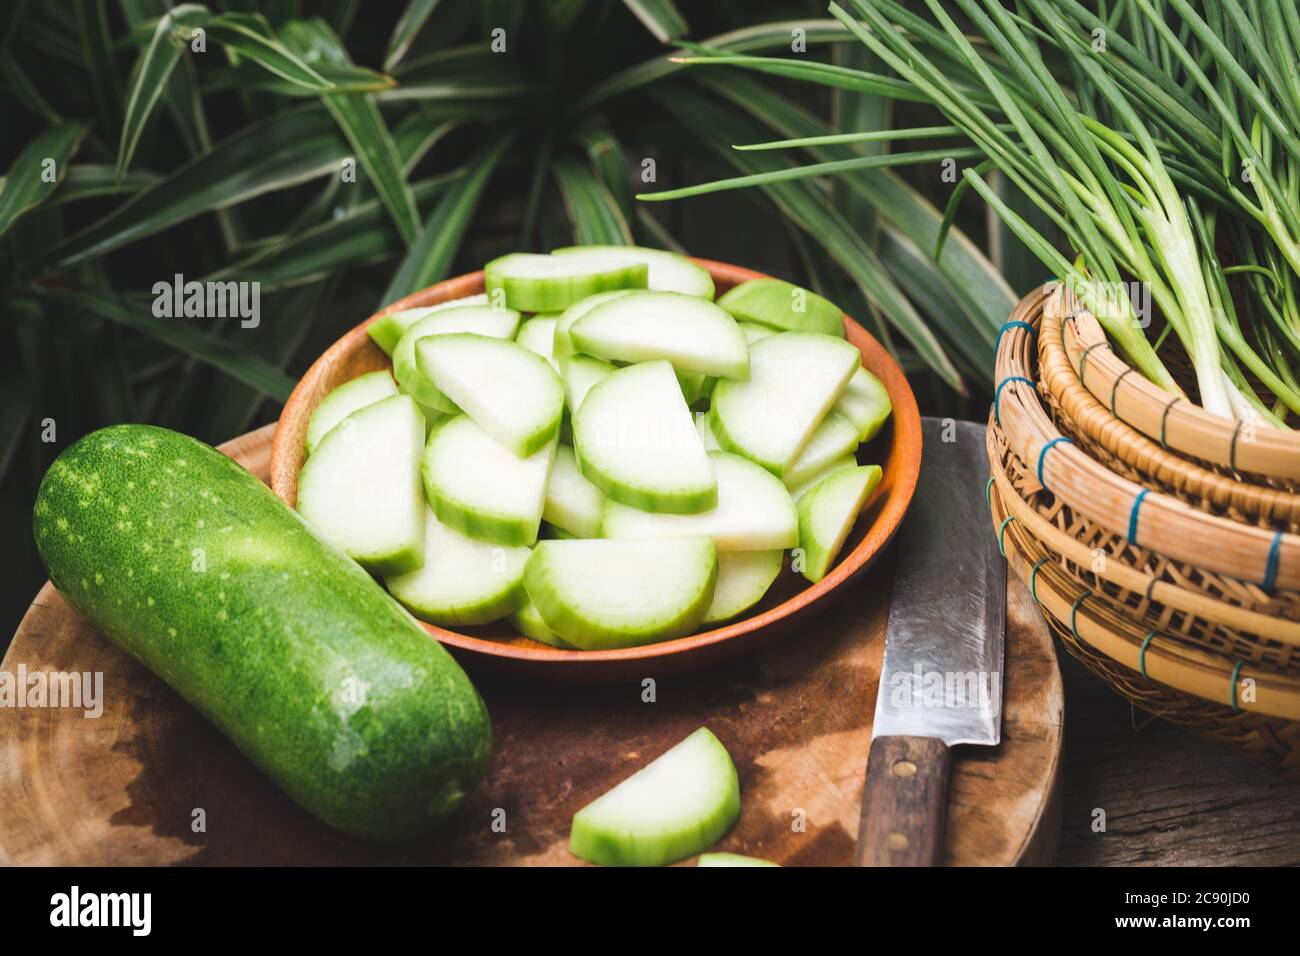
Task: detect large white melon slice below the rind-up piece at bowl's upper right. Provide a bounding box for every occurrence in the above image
[709,332,861,476]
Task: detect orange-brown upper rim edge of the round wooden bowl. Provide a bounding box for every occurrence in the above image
[270,258,922,666]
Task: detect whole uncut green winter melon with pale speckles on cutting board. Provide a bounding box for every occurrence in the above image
[34,425,491,840]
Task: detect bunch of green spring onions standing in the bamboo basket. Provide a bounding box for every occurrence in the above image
[831,0,1300,425]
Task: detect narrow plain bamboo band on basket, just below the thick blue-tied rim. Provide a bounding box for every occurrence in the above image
[987,421,1300,648]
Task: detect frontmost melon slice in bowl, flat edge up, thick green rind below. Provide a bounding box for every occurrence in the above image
[524,537,718,650]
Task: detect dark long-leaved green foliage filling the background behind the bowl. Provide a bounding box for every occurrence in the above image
[0,0,1040,641]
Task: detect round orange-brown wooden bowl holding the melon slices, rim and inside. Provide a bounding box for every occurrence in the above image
[270,259,920,683]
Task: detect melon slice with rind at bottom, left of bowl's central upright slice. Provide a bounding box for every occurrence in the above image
[420,415,555,548]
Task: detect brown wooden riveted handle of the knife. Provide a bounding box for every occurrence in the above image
[854,737,949,866]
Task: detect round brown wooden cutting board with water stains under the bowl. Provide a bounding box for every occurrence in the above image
[0,427,1063,865]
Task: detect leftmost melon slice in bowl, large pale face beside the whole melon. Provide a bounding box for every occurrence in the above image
[298,395,424,574]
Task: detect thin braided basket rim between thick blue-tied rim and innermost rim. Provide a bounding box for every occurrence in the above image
[1039,303,1300,525]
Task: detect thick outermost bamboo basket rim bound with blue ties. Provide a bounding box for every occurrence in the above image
[993,286,1300,593]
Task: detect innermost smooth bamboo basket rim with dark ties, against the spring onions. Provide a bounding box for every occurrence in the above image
[1049,286,1300,481]
